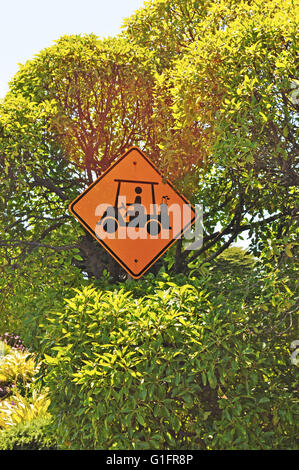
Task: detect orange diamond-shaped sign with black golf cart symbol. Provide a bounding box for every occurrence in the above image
[69,147,195,279]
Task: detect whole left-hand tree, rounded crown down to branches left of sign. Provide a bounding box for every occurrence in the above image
[1,35,159,277]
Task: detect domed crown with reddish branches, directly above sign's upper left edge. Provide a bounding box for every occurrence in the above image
[11,34,156,174]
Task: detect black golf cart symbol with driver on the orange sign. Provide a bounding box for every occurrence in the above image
[98,179,171,235]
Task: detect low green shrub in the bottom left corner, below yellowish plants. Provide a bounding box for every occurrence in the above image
[0,418,57,450]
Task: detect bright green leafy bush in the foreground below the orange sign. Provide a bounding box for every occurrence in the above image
[43,281,296,449]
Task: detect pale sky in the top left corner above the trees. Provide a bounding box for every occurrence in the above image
[0,0,144,98]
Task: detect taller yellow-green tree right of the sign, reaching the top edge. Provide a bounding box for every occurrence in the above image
[124,0,298,266]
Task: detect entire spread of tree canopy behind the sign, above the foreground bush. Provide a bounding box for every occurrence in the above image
[0,0,298,286]
